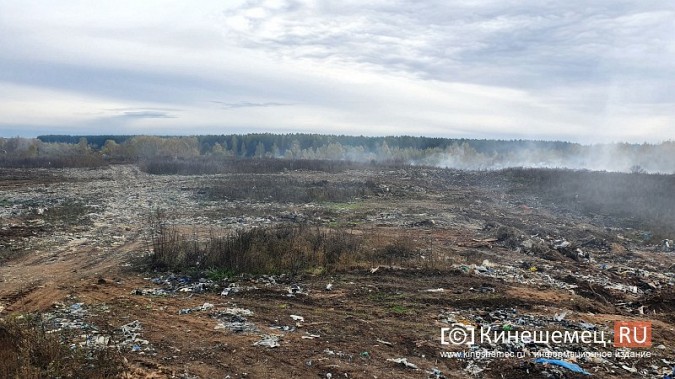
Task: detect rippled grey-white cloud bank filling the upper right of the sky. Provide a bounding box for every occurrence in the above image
[226,0,675,95]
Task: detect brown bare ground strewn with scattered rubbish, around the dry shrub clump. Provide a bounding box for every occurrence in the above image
[0,166,675,378]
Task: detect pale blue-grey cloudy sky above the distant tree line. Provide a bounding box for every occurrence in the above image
[0,0,675,143]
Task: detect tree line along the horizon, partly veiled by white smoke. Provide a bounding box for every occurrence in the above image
[0,133,675,174]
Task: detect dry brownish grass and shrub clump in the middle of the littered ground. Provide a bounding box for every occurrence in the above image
[150,212,363,275]
